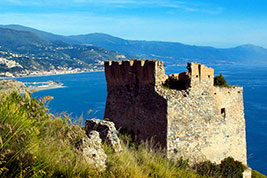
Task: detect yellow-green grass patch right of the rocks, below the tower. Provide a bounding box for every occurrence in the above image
[102,136,205,178]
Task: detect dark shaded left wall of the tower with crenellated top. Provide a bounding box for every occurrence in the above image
[104,60,167,147]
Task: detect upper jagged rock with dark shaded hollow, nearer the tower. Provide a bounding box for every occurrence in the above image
[85,119,122,152]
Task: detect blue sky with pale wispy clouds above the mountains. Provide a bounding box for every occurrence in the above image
[0,0,267,48]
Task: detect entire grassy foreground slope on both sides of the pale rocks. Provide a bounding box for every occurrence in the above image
[0,92,266,178]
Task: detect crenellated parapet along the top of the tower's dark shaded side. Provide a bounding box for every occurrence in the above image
[105,59,167,90]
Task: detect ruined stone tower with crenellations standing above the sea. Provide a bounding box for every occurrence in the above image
[105,60,247,168]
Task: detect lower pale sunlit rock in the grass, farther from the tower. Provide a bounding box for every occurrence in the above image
[77,131,107,170]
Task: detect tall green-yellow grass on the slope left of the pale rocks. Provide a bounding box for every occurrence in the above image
[0,92,96,177]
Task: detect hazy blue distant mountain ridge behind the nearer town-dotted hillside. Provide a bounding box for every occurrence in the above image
[2,25,267,64]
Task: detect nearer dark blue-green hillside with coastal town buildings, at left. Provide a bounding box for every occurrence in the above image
[0,28,124,73]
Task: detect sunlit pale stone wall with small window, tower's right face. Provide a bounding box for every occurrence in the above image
[163,87,247,165]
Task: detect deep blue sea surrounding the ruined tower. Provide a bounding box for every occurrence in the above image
[13,65,267,175]
